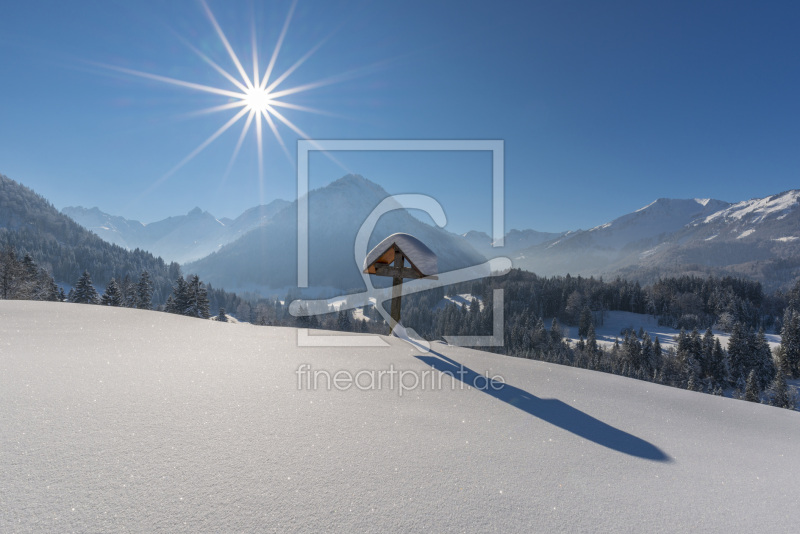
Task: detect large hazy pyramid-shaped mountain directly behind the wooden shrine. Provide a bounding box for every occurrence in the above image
[185,175,484,290]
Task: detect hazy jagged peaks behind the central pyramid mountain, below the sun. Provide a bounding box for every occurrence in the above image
[62,200,289,263]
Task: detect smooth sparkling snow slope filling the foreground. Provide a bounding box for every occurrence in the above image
[0,301,800,532]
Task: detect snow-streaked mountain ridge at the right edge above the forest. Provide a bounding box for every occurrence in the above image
[514,190,800,287]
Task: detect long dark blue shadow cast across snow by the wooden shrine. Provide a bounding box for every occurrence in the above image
[416,350,672,462]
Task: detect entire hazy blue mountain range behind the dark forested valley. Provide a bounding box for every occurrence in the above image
[9,175,800,292]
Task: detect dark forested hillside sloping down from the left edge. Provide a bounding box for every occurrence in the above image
[0,175,178,302]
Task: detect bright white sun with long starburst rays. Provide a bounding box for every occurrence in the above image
[101,0,349,201]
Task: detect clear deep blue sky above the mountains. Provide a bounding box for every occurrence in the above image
[0,0,800,232]
